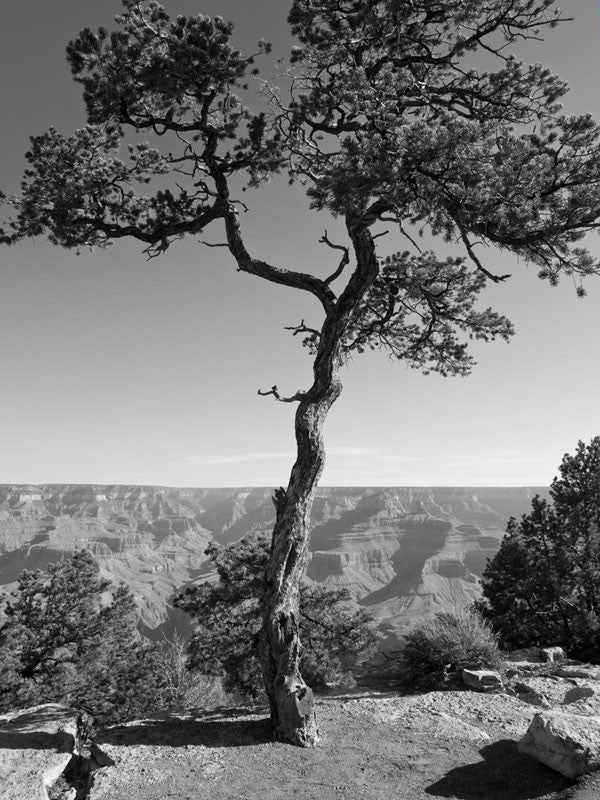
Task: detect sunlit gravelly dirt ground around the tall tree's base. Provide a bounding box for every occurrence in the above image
[85,679,600,800]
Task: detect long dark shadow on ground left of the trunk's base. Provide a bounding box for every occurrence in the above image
[97,709,273,747]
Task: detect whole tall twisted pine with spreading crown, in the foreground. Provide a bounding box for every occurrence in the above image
[2,0,600,745]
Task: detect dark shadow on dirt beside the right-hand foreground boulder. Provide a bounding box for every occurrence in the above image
[425,739,575,800]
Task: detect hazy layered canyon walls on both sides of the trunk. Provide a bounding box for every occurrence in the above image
[0,485,547,644]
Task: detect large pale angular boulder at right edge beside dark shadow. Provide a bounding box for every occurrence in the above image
[518,711,600,778]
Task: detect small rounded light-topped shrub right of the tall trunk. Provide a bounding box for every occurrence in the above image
[402,609,502,687]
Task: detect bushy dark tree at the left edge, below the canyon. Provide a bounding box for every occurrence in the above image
[0,550,162,721]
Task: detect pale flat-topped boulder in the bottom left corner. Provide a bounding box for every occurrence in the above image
[0,703,78,800]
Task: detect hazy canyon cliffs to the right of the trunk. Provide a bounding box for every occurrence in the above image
[308,488,548,647]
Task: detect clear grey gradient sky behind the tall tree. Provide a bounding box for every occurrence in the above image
[0,0,600,487]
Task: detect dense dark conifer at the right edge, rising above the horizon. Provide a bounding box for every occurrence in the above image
[479,437,600,660]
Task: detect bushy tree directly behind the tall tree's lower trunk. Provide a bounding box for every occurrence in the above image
[175,536,380,698]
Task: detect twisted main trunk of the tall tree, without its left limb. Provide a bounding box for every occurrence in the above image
[262,219,378,747]
